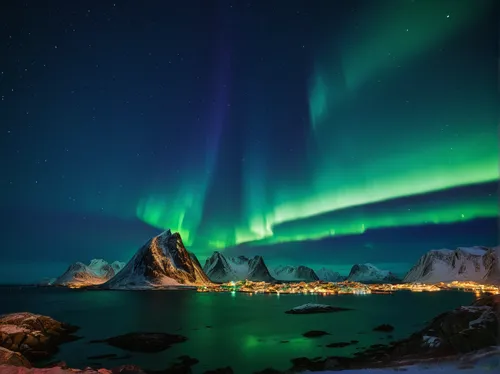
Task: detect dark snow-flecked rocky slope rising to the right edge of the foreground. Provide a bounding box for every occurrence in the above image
[284,295,500,372]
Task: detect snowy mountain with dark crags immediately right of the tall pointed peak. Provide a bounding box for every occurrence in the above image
[203,252,274,282]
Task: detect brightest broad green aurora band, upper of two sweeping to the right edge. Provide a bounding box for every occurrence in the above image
[269,147,499,225]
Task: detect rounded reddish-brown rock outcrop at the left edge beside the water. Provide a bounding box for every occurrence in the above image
[0,313,80,362]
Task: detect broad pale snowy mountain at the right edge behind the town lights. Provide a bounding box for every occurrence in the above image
[403,247,500,283]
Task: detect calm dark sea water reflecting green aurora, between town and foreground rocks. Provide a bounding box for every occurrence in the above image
[0,288,474,374]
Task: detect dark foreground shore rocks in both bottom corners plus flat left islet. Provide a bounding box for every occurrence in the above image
[0,295,500,374]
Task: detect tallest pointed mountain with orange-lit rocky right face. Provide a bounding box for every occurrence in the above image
[101,230,210,289]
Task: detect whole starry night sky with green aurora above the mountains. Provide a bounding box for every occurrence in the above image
[0,0,499,282]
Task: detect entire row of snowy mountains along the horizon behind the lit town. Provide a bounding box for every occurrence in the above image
[47,230,500,289]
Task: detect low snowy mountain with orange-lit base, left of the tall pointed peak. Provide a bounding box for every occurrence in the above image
[51,259,123,287]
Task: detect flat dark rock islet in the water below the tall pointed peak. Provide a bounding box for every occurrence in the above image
[90,332,187,353]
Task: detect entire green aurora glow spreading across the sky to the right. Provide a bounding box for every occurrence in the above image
[136,0,499,253]
